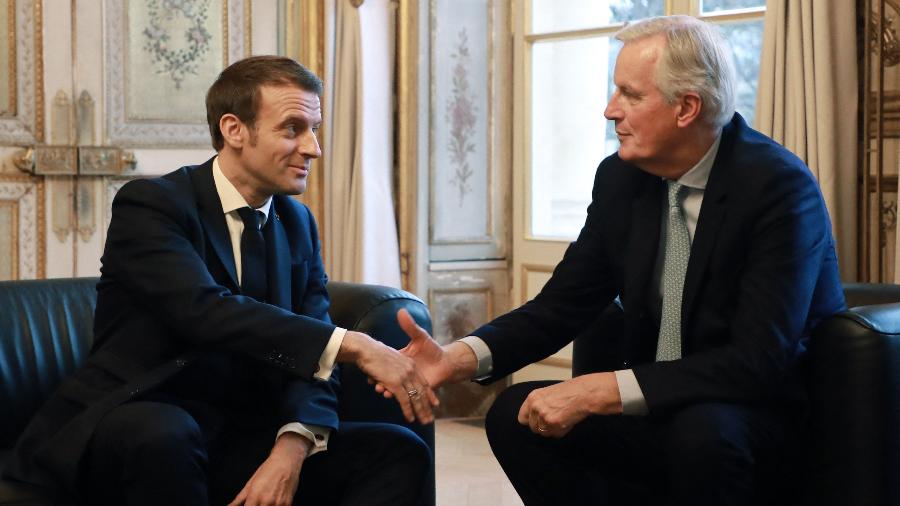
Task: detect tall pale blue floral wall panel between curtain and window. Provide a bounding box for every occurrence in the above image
[429,0,509,260]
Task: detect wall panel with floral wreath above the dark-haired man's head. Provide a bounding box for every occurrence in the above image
[105,0,250,147]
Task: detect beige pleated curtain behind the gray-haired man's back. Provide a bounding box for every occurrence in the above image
[756,0,857,281]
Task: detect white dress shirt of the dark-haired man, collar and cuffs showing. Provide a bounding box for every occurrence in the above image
[212,158,347,455]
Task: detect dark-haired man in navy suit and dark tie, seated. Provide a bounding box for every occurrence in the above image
[6,56,437,506]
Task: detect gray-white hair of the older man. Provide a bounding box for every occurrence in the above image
[616,16,735,127]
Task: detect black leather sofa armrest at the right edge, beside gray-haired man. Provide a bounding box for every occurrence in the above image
[808,303,900,505]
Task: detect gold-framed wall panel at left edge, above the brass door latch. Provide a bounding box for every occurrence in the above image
[0,0,44,145]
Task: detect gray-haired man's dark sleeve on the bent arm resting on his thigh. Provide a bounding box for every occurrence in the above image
[634,163,843,412]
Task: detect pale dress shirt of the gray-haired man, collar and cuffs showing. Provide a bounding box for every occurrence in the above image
[459,133,722,415]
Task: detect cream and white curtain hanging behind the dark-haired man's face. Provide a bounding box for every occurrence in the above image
[323,0,400,287]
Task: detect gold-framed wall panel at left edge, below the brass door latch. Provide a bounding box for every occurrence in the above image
[0,175,46,280]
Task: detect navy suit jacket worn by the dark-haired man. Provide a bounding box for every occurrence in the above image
[5,160,338,492]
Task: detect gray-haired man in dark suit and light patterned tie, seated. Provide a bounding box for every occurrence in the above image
[400,16,844,505]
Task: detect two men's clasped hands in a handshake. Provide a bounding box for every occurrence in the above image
[337,309,477,424]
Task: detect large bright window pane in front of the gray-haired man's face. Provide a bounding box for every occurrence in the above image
[530,37,620,237]
